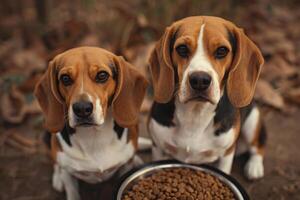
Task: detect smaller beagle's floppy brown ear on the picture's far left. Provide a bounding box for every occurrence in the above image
[34,58,65,133]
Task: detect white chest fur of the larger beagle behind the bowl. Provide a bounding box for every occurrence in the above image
[149,102,234,163]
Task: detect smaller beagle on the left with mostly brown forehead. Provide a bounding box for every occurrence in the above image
[35,47,147,200]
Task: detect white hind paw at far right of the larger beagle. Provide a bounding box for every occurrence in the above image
[245,155,264,180]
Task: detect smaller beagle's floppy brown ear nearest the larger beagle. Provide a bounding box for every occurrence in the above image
[112,56,148,127]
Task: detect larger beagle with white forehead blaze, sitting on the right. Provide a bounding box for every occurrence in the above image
[148,16,266,179]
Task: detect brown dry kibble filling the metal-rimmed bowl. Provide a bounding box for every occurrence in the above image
[122,168,236,200]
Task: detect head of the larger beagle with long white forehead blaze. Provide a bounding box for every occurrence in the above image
[150,16,264,107]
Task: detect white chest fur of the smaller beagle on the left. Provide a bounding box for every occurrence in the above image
[57,115,134,183]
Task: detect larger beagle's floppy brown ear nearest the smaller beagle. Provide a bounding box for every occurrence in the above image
[149,25,177,103]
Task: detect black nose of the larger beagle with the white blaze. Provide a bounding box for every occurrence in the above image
[189,72,211,91]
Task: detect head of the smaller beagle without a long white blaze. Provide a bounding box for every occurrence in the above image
[35,47,147,132]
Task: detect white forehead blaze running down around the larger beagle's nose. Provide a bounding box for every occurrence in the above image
[179,24,221,103]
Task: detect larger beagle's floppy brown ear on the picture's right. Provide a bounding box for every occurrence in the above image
[227,27,264,108]
